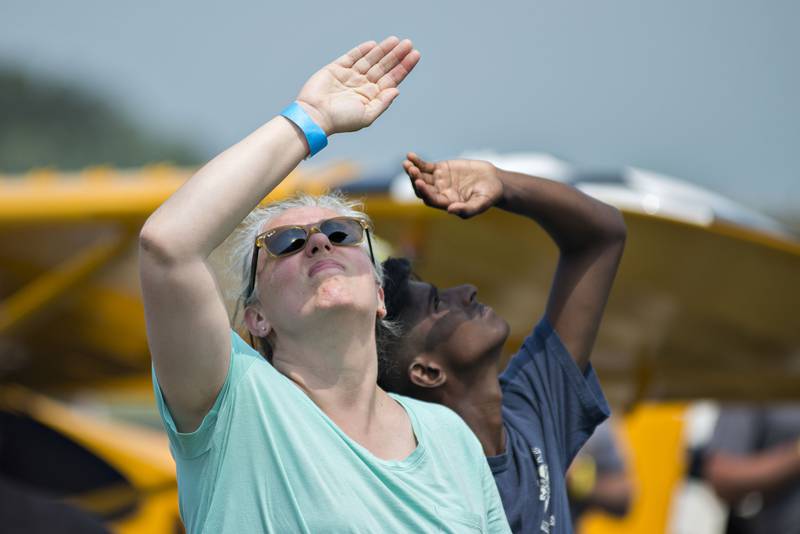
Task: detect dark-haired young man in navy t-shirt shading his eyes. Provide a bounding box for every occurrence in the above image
[381,153,625,532]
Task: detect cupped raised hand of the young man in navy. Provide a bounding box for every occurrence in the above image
[403,152,503,219]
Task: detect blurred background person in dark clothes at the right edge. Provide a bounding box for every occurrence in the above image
[704,404,800,534]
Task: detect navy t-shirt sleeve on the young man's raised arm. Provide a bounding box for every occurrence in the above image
[500,317,610,470]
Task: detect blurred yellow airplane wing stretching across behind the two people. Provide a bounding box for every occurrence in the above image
[0,164,800,404]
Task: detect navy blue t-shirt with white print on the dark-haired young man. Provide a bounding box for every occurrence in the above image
[487,318,610,533]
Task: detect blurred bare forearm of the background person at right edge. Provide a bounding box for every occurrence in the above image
[705,440,800,505]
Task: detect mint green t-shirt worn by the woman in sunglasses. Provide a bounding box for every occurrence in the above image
[153,333,510,534]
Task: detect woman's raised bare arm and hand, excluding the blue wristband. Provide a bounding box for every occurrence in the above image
[139,37,419,432]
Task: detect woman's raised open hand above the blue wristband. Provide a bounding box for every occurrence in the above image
[297,37,420,135]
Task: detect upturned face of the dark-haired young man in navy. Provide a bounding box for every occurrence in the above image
[404,280,509,370]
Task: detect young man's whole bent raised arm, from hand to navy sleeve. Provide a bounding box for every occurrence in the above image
[403,153,626,369]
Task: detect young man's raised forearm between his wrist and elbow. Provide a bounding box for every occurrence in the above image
[497,169,625,254]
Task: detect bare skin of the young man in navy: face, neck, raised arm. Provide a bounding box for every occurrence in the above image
[396,153,626,456]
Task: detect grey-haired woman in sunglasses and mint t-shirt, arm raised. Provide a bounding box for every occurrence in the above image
[140,37,508,533]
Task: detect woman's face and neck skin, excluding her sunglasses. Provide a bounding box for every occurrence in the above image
[245,208,416,459]
